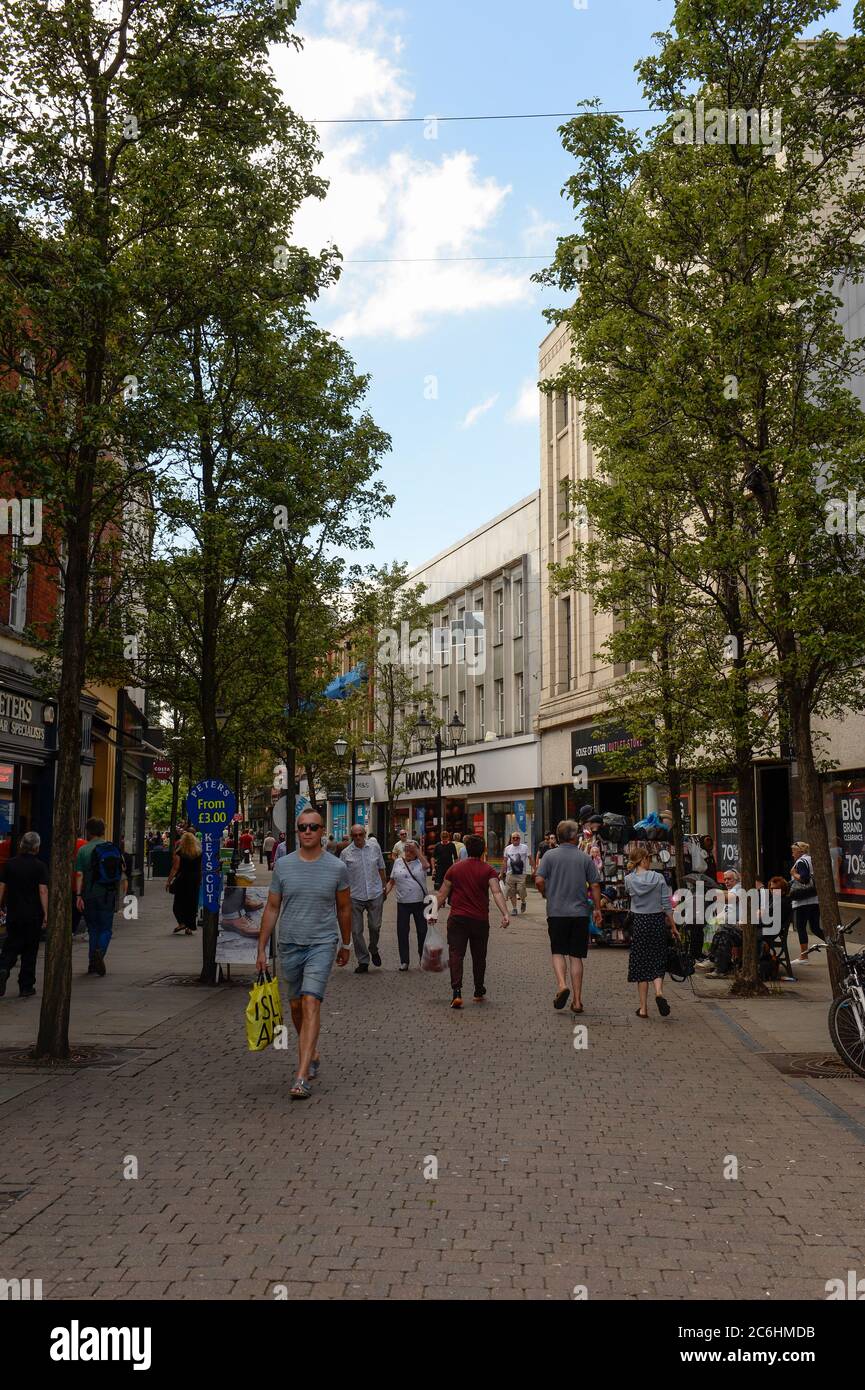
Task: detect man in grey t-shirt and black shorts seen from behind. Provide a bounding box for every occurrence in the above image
[534,820,604,1013]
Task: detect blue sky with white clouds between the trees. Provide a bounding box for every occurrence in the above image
[273,0,854,569]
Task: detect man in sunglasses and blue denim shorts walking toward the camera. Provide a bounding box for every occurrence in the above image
[256,808,352,1101]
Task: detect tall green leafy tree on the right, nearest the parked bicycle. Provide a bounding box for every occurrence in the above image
[545,0,865,1000]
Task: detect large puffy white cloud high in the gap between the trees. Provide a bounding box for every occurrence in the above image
[273,0,533,339]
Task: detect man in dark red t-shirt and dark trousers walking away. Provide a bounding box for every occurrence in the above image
[435,835,510,1009]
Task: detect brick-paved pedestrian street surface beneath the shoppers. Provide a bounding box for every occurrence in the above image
[0,890,865,1301]
